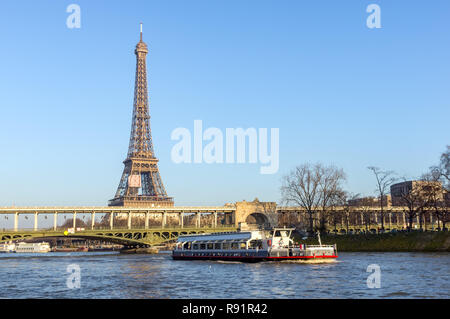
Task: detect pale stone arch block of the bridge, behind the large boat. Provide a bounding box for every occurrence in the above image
[234,198,278,227]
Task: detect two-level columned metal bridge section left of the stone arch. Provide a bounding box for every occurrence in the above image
[0,206,237,247]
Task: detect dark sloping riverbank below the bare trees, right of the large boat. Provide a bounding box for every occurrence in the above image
[297,232,450,252]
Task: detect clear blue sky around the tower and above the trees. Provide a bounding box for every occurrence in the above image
[0,0,450,206]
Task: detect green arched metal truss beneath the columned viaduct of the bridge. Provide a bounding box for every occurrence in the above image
[0,227,236,247]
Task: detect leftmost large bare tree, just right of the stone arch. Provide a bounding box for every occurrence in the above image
[281,163,320,234]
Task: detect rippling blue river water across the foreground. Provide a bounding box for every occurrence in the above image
[0,253,450,298]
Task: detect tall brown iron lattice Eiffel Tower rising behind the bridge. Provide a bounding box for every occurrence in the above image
[109,23,173,207]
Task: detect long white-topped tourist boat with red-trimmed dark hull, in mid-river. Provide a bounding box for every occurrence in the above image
[172,228,337,262]
